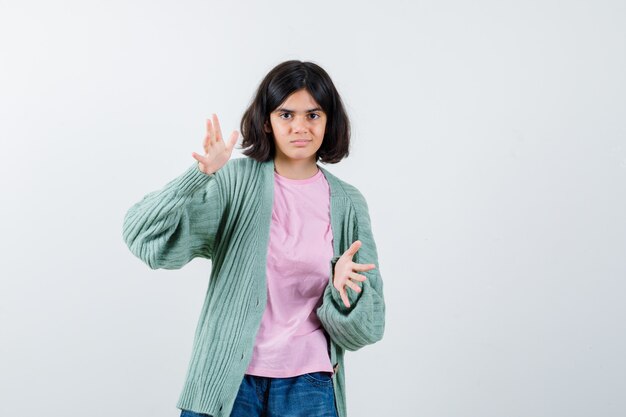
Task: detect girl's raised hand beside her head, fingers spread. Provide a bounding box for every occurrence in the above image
[191,114,239,175]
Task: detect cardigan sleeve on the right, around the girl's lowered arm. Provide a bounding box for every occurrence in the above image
[317,192,385,351]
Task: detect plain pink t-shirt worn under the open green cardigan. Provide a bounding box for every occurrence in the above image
[246,169,333,378]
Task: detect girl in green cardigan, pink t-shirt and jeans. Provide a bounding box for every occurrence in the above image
[124,61,385,417]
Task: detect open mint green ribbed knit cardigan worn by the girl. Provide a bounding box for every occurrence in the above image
[123,157,385,417]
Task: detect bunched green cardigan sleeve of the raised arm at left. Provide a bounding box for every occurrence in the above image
[123,163,224,269]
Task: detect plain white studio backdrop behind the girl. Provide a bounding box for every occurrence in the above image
[0,0,626,417]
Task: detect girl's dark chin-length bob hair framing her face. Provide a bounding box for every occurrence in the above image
[240,60,350,164]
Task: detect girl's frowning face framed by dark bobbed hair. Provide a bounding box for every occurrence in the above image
[266,89,326,164]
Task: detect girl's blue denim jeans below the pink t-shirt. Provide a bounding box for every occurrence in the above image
[180,372,338,417]
